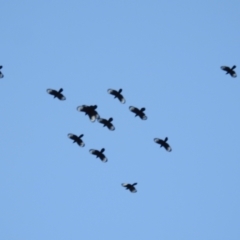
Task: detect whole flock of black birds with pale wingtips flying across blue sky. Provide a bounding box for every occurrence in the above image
[0,65,237,193]
